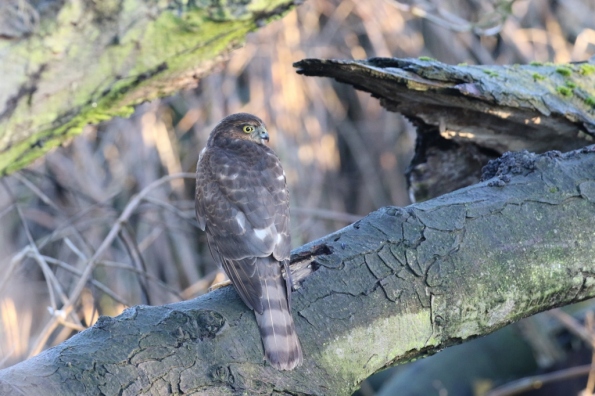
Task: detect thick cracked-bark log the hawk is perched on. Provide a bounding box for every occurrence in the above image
[0,146,595,395]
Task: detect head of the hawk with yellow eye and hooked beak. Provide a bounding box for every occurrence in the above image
[207,113,269,144]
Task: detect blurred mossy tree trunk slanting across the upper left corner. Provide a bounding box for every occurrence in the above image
[0,0,299,175]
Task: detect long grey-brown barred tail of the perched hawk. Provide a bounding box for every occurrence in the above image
[254,257,303,370]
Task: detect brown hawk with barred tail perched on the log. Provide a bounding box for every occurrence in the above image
[195,113,303,370]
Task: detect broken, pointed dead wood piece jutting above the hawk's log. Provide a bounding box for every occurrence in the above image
[294,58,595,201]
